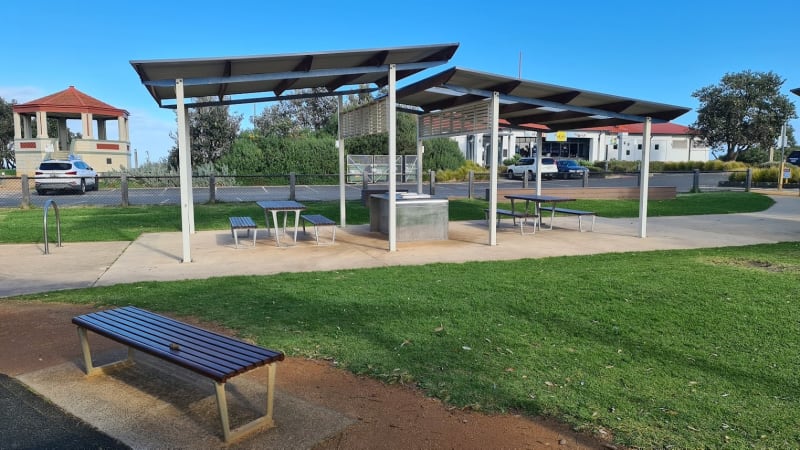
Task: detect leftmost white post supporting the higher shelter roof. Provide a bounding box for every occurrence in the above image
[175,79,193,263]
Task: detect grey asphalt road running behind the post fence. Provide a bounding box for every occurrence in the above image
[0,173,728,208]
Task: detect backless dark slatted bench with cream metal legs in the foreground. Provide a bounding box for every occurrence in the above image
[72,306,284,443]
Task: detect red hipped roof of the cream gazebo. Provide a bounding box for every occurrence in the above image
[13,86,128,119]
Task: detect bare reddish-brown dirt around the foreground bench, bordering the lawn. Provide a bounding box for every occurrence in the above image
[0,300,614,449]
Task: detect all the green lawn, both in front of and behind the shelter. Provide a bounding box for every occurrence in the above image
[0,193,800,448]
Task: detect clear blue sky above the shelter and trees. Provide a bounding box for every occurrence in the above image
[0,0,800,163]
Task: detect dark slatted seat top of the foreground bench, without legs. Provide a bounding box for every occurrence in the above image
[72,307,284,382]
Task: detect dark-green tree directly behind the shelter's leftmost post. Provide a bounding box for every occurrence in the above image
[168,97,242,168]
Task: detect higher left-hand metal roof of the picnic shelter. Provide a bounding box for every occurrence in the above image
[130,44,458,107]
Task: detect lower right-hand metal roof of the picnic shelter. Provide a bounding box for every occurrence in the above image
[397,67,690,130]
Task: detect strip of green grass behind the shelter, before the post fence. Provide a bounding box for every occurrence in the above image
[0,192,774,244]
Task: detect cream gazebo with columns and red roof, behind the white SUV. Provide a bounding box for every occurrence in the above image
[13,86,131,175]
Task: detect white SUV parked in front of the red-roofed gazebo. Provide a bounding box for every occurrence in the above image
[35,159,98,195]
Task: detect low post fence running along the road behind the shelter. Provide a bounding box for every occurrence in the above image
[0,171,780,208]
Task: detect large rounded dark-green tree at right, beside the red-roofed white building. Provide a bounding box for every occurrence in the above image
[692,70,797,161]
